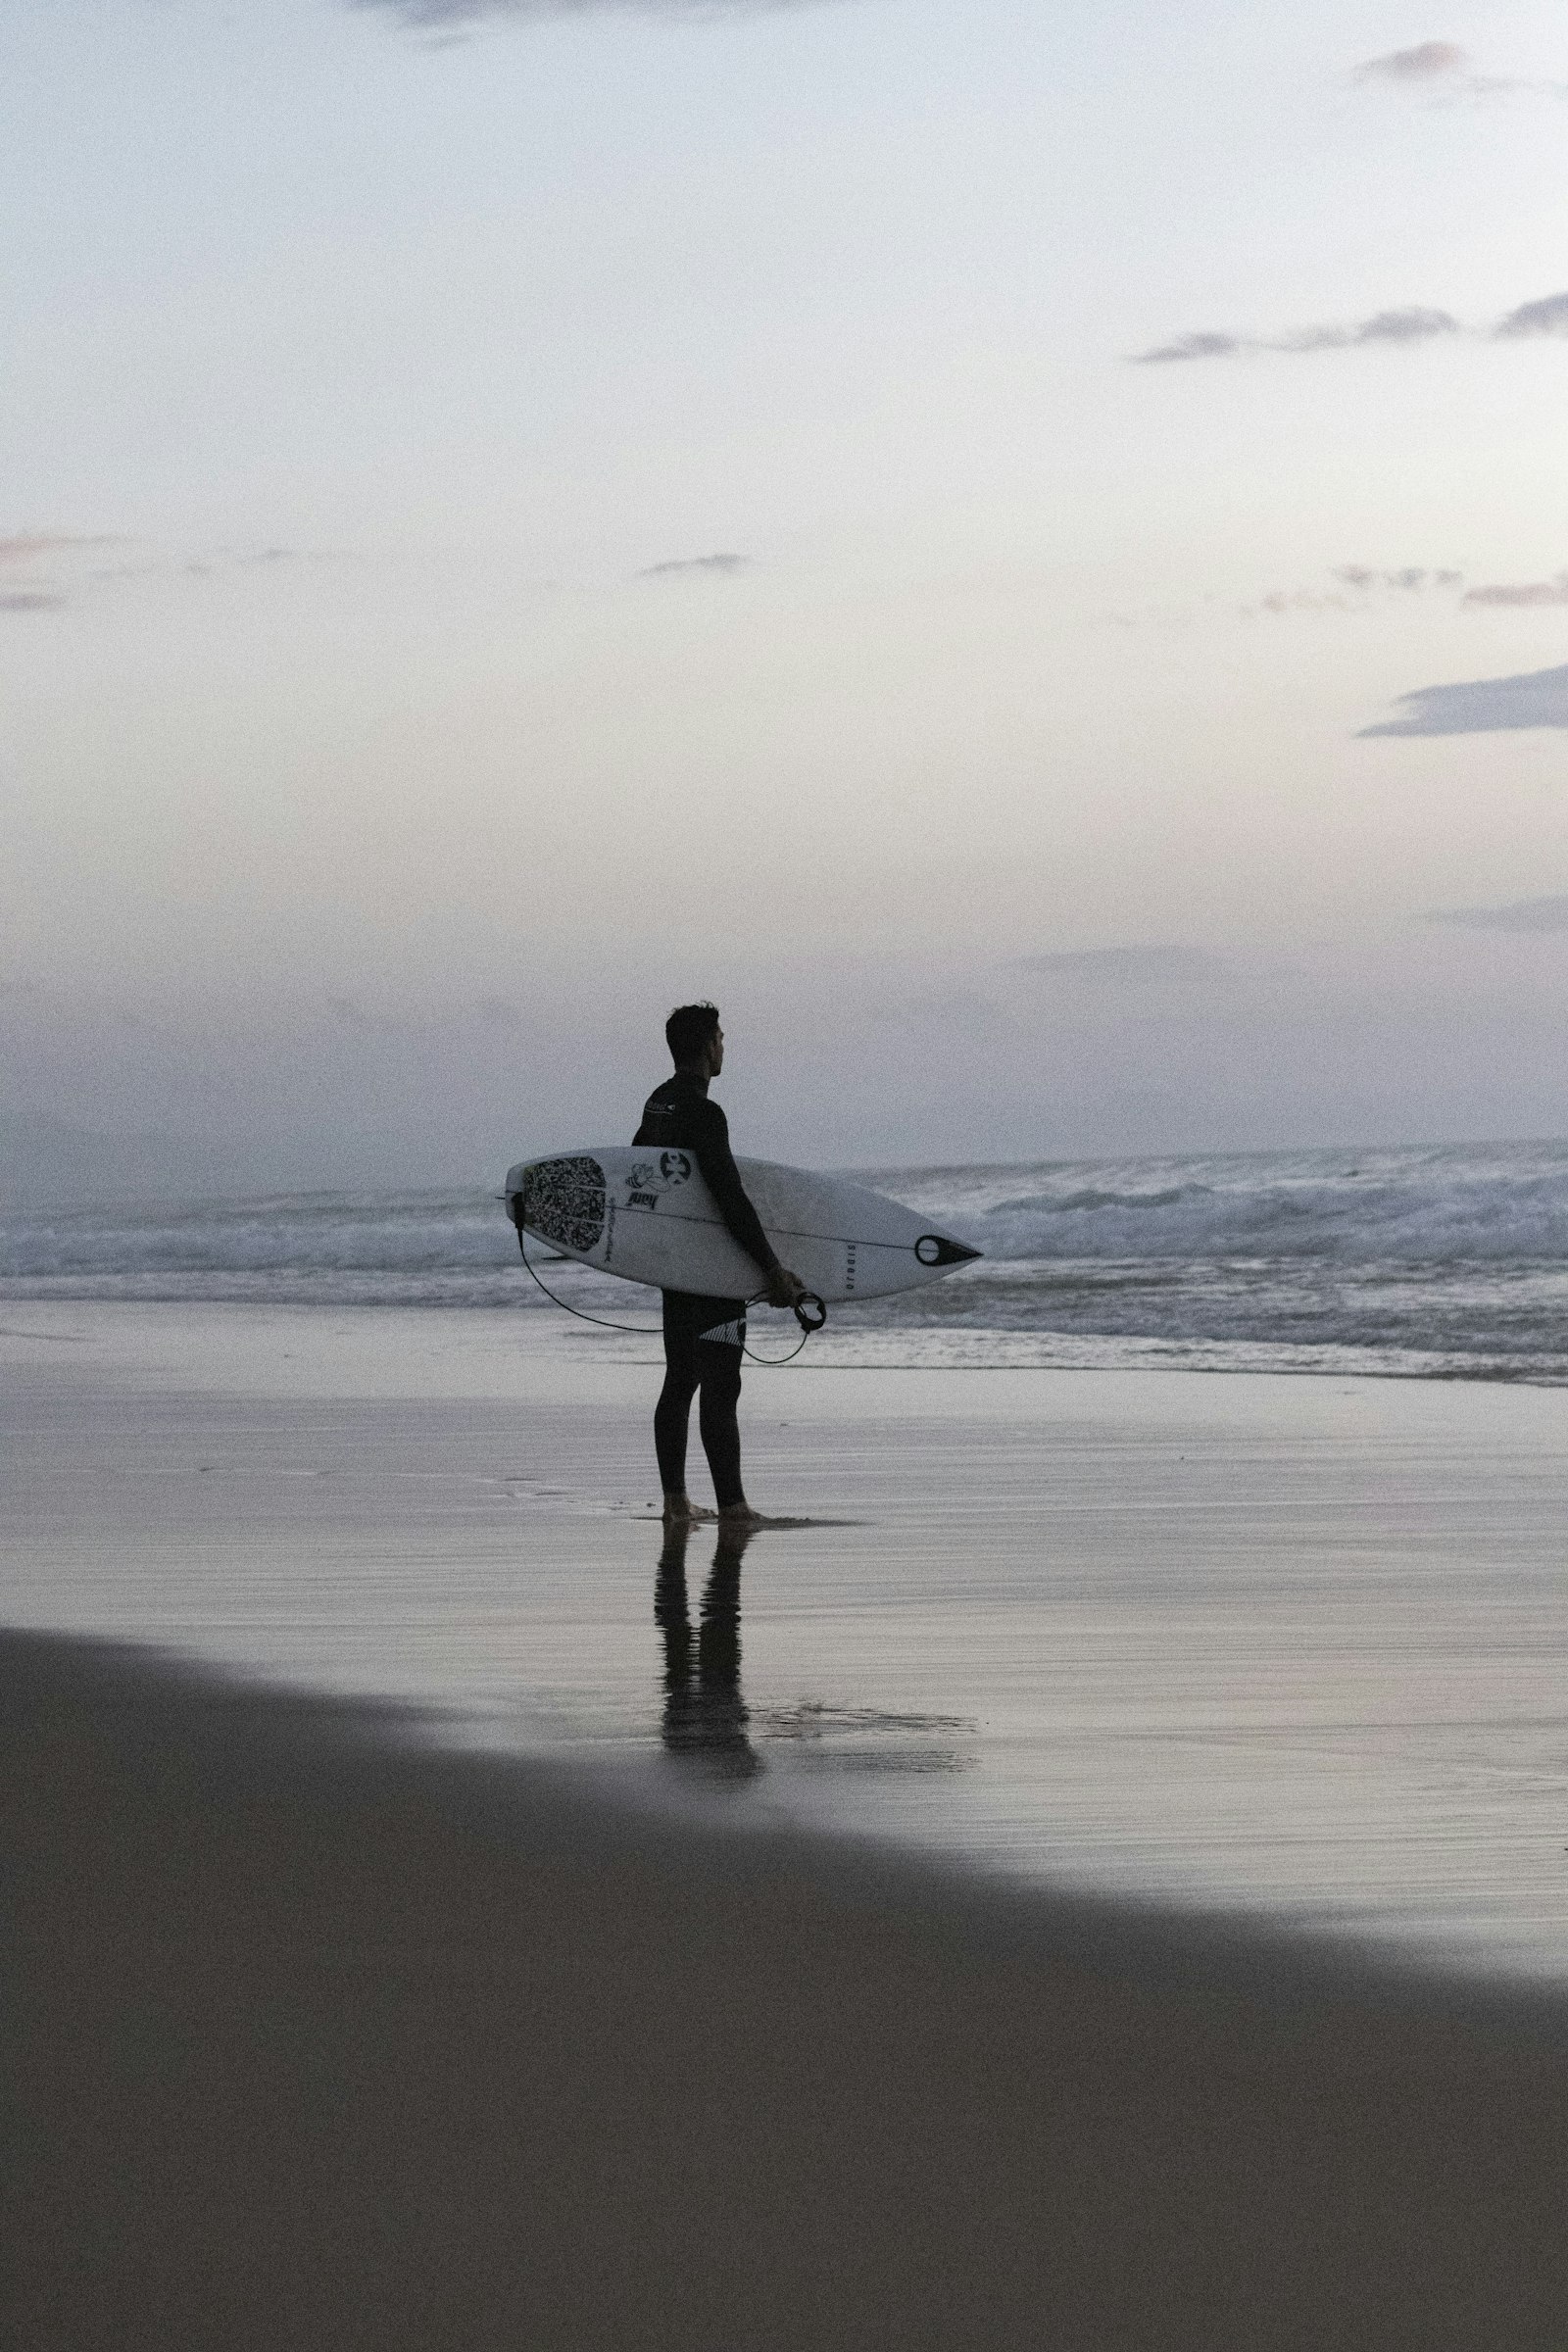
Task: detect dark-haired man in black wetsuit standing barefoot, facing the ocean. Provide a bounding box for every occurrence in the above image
[632,1004,804,1527]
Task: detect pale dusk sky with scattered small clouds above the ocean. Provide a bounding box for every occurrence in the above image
[0,0,1568,1183]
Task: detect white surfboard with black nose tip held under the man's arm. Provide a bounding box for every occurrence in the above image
[506,1143,980,1305]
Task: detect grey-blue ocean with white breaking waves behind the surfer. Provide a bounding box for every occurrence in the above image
[0,1143,1568,1386]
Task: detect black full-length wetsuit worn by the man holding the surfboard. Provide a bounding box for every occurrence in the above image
[632,1070,778,1510]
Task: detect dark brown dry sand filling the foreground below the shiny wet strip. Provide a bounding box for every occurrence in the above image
[0,1635,1568,2352]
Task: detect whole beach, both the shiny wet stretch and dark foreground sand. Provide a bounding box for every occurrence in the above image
[0,1303,1568,2352]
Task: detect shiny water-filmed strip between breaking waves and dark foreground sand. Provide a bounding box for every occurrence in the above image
[0,1303,1568,1978]
